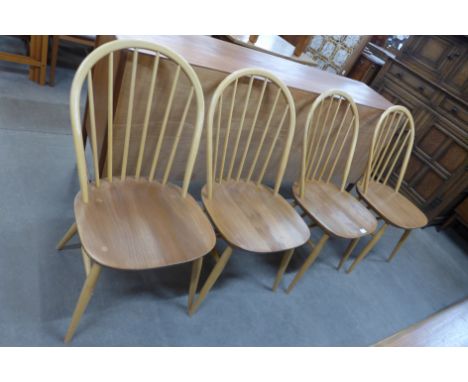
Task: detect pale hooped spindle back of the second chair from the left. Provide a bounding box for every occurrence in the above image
[206,68,296,198]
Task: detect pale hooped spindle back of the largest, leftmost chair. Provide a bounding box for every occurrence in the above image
[70,40,204,202]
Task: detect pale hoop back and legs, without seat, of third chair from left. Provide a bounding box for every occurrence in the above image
[275,89,372,293]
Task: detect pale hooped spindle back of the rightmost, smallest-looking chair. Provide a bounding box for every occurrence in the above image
[364,106,414,193]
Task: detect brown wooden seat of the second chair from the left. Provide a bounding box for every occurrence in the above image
[202,181,310,253]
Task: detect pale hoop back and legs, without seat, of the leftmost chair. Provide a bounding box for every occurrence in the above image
[57,40,210,342]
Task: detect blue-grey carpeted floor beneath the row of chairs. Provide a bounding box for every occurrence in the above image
[0,38,468,346]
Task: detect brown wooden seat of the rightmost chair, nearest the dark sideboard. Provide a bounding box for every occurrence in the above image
[356,181,427,229]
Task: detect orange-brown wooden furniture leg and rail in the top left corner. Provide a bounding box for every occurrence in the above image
[0,35,49,85]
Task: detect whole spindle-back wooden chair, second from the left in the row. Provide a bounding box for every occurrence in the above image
[189,69,310,314]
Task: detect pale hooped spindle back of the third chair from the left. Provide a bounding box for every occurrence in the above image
[300,89,359,197]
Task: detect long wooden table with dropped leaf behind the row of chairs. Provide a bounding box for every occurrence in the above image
[85,36,392,184]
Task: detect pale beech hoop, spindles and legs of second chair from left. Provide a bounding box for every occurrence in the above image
[189,68,308,314]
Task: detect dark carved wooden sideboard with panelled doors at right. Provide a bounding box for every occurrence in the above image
[372,36,468,224]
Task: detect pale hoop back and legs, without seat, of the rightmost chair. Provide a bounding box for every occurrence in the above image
[347,105,422,273]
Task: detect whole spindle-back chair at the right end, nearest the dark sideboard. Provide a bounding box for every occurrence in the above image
[348,106,427,273]
